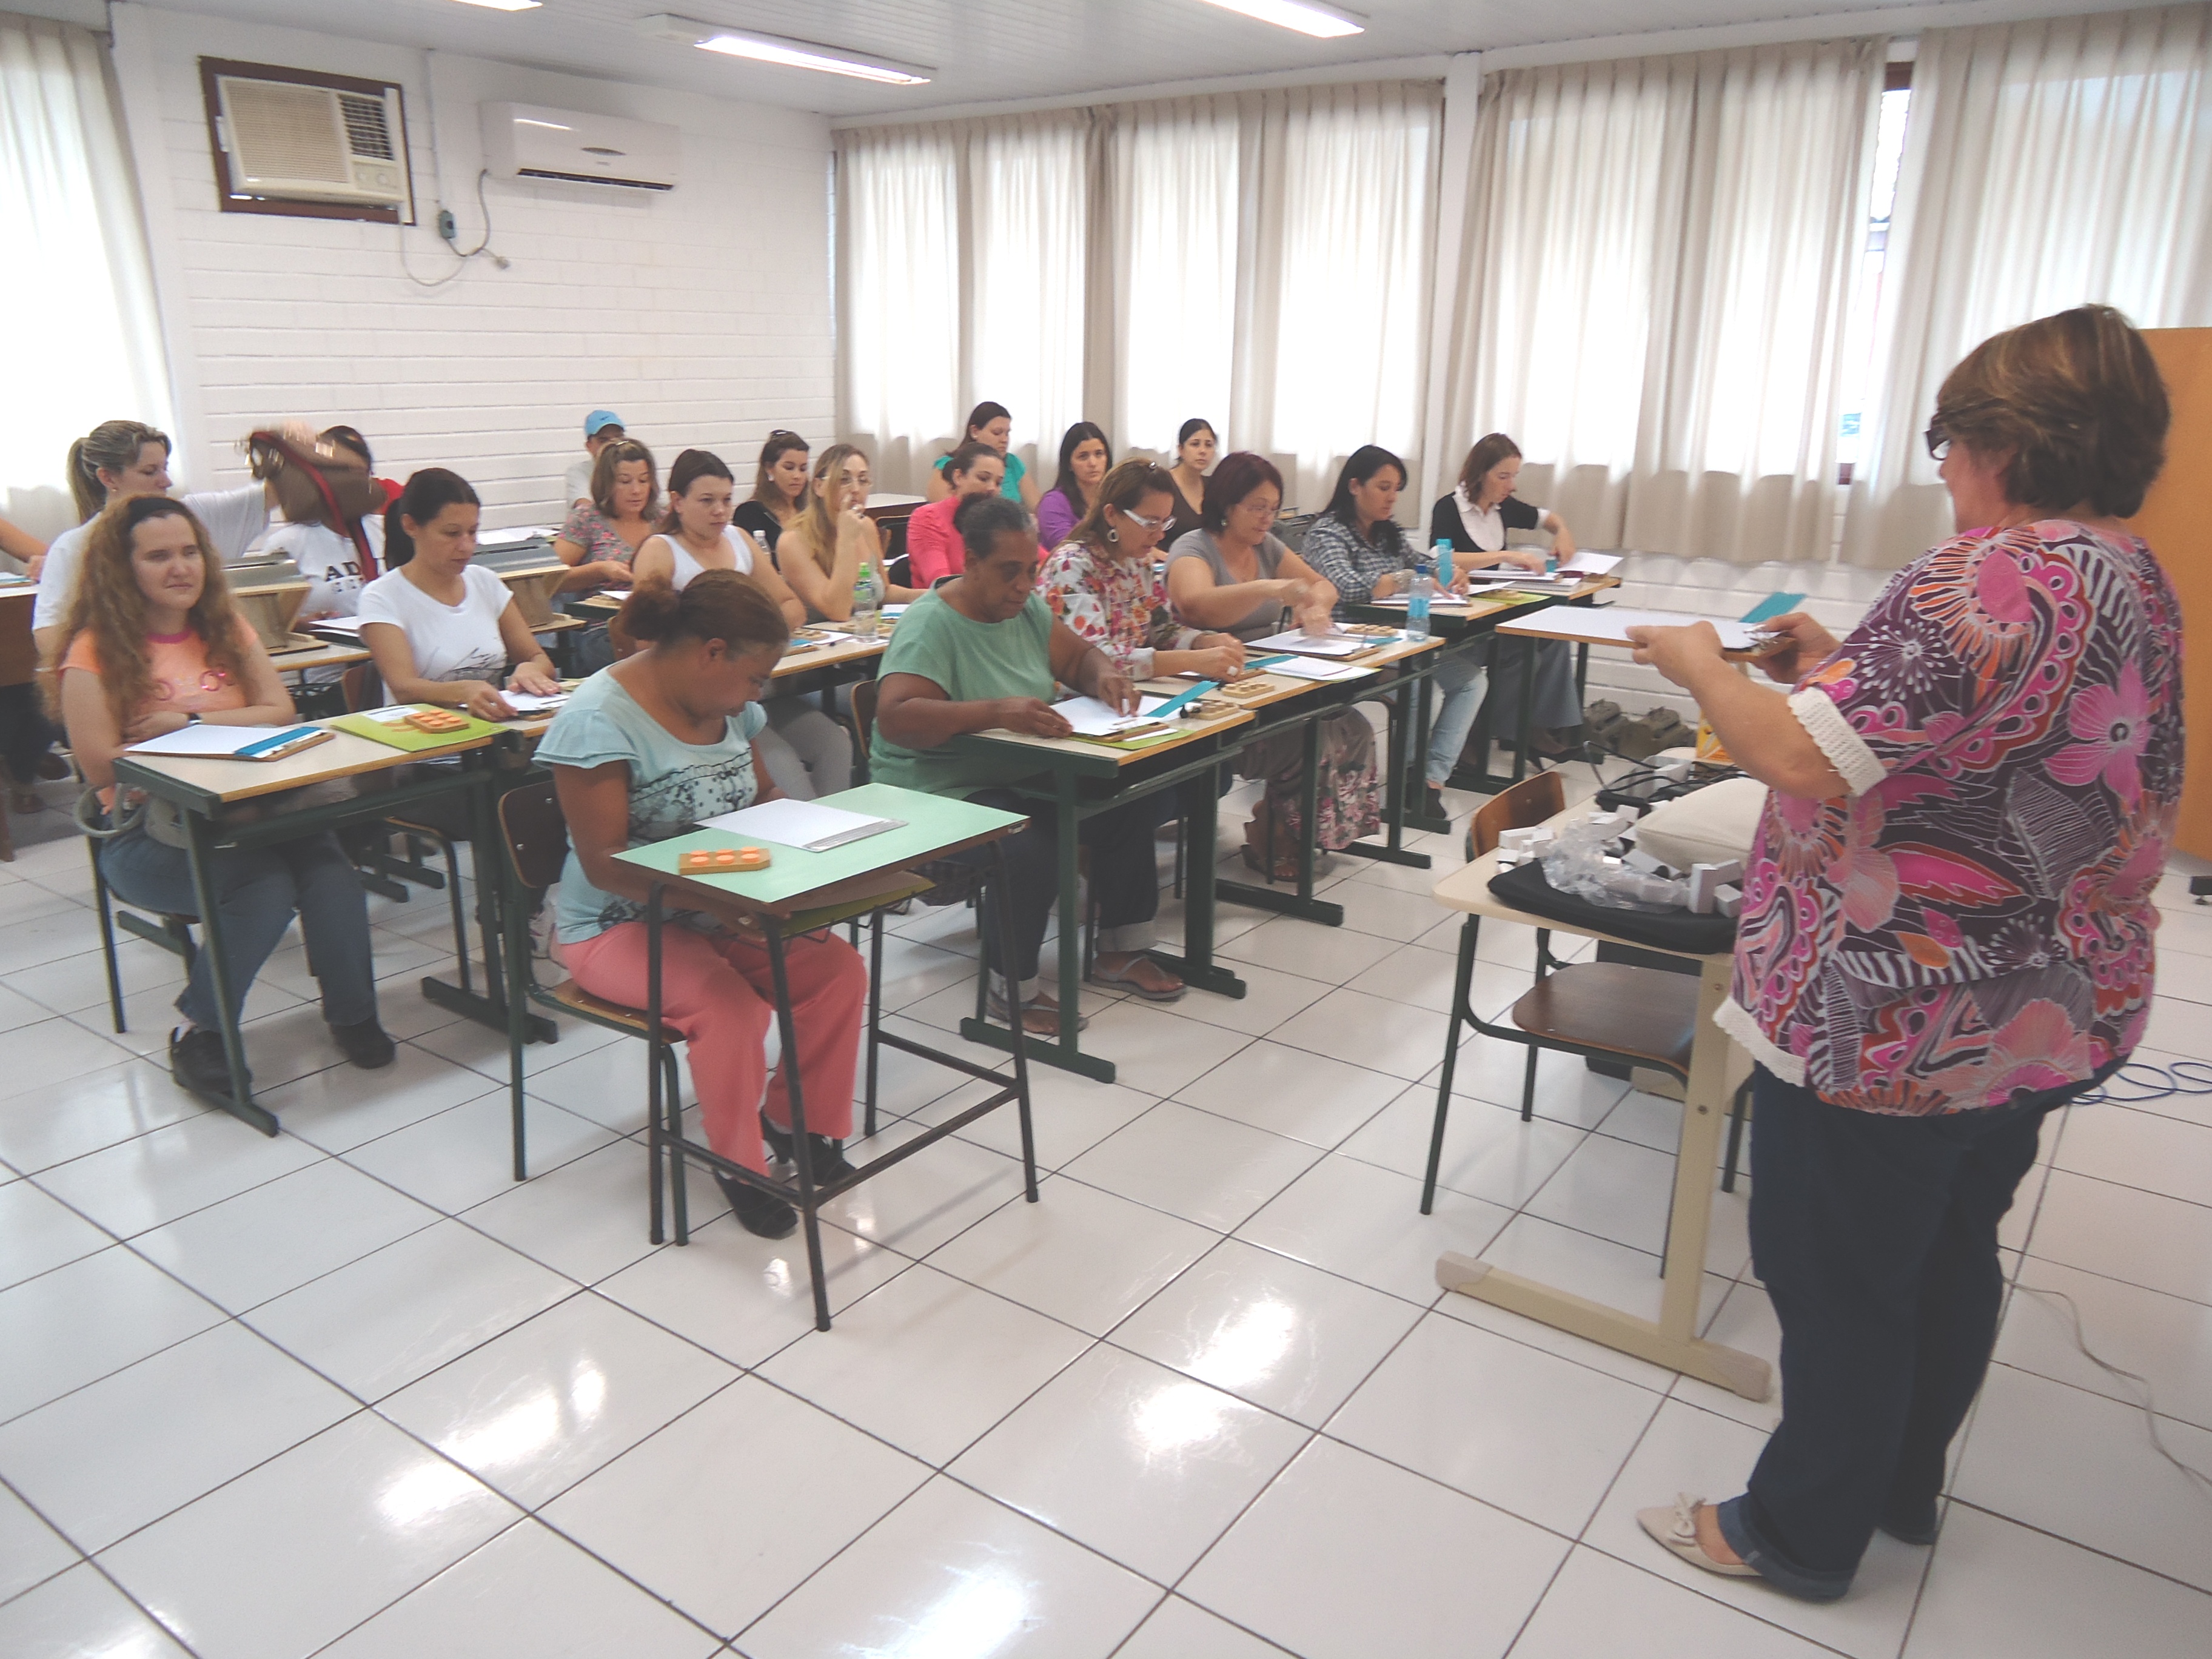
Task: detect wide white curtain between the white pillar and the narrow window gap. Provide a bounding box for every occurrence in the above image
[1429,40,1885,564]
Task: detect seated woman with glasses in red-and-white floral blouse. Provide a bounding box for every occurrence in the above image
[1040,460,1243,679]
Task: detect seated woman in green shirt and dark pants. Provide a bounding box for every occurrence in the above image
[870,495,1184,1037]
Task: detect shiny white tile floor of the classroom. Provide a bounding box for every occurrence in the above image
[0,783,2212,1659]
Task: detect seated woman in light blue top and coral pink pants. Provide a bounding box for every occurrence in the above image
[537,571,867,1239]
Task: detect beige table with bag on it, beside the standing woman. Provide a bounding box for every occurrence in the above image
[1431,809,1772,1400]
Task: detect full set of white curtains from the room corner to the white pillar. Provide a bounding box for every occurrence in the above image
[839,82,1442,506]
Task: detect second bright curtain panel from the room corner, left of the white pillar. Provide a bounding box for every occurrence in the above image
[977,110,1090,473]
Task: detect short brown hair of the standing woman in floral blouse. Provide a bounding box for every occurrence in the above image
[1936,305,2172,518]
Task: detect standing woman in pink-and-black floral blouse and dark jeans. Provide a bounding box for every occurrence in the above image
[1631,305,2181,1601]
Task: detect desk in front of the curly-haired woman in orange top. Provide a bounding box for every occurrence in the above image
[112,732,531,1134]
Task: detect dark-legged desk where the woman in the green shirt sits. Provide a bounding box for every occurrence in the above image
[947,703,1254,1084]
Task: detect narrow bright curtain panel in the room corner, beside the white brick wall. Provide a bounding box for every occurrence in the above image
[836,124,965,489]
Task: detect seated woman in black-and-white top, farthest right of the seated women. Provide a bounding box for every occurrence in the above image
[1429,431,1581,763]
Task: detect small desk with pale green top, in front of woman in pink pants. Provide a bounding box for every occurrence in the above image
[610,783,1037,1332]
